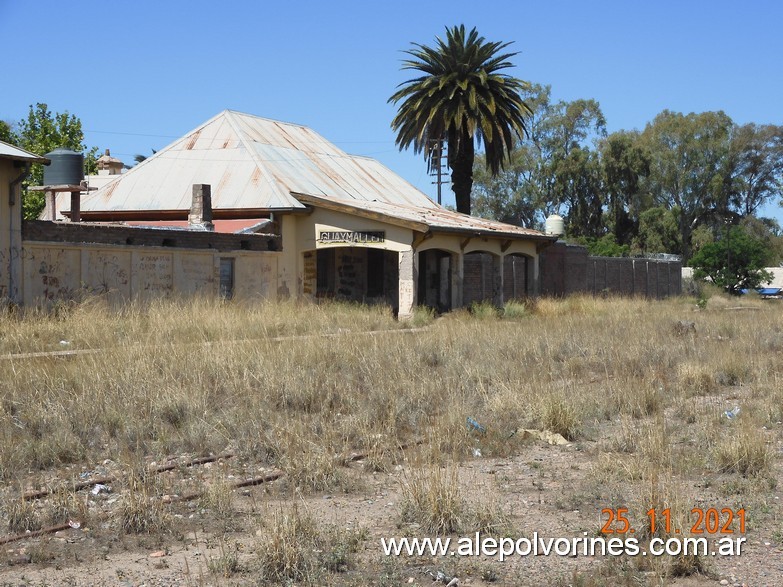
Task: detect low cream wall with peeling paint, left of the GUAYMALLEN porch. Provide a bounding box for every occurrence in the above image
[22,242,280,305]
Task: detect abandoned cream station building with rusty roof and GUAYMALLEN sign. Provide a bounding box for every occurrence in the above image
[0,111,556,317]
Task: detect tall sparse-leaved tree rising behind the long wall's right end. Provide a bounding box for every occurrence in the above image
[640,110,733,260]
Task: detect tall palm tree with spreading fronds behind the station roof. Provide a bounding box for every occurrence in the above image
[389,25,531,214]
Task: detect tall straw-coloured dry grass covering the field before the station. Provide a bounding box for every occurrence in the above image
[0,296,783,581]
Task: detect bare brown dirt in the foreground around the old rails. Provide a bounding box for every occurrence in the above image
[0,420,783,587]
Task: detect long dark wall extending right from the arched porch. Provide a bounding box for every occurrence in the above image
[540,243,682,298]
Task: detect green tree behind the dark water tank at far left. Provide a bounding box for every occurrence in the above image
[14,102,98,219]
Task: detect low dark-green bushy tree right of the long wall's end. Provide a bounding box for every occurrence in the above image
[690,226,772,294]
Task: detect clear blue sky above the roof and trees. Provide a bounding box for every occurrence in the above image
[0,0,783,219]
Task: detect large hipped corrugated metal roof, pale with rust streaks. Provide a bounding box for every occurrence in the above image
[81,110,437,212]
